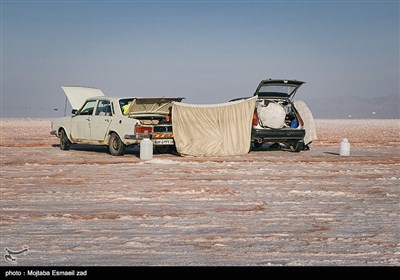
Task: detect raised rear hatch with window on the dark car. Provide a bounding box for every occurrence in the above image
[254,79,305,99]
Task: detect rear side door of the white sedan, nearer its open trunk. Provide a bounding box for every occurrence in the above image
[90,100,113,142]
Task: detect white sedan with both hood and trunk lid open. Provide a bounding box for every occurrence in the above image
[50,87,183,156]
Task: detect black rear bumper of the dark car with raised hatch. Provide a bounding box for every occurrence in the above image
[251,128,306,142]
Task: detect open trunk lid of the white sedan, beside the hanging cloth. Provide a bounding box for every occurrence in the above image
[128,97,184,115]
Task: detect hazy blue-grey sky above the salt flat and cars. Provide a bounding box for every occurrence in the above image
[0,0,400,118]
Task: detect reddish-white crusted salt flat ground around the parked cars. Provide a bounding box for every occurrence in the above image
[0,119,400,266]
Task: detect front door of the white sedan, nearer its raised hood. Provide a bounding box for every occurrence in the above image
[71,100,97,142]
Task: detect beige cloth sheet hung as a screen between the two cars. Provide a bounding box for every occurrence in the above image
[172,97,257,157]
